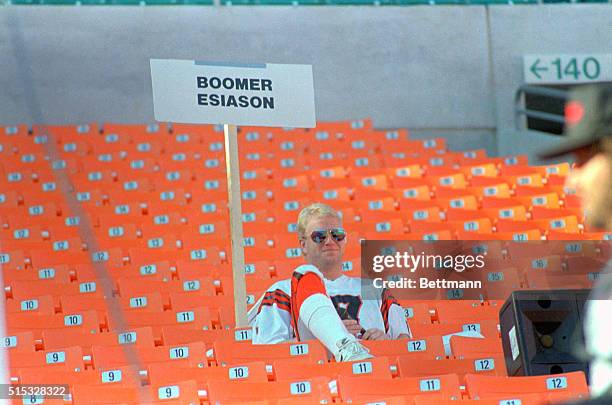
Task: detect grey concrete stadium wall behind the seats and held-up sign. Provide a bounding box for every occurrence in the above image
[0,5,612,159]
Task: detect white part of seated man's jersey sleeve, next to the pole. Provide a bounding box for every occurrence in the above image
[252,303,294,344]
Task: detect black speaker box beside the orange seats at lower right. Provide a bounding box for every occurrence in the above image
[499,290,590,376]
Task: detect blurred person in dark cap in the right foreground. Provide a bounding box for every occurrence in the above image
[540,84,612,404]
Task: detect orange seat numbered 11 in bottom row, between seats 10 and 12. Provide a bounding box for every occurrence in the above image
[338,374,461,403]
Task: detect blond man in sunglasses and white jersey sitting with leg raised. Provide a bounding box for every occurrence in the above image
[249,203,410,361]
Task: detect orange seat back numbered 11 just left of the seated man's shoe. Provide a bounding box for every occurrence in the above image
[211,340,327,365]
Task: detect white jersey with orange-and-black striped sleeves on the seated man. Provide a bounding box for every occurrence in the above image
[249,276,410,344]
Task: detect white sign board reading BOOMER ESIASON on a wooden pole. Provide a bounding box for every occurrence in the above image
[151,59,316,128]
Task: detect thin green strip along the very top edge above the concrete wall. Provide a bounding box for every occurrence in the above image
[7,0,609,6]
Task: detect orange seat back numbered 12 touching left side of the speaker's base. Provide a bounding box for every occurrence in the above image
[397,356,506,378]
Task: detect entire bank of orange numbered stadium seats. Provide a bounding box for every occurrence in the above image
[0,120,609,405]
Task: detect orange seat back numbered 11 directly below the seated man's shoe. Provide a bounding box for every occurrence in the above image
[272,357,392,381]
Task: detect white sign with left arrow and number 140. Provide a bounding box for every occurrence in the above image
[523,54,612,84]
